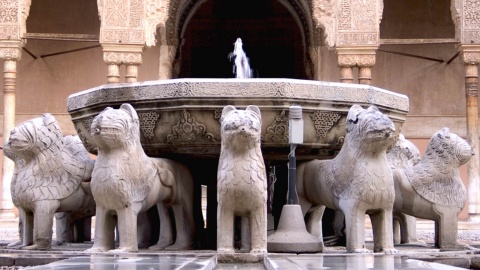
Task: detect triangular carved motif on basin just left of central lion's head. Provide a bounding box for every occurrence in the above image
[167,110,215,144]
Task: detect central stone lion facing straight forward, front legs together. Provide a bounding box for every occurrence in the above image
[217,105,267,253]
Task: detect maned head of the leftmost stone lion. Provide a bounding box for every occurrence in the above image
[4,113,63,160]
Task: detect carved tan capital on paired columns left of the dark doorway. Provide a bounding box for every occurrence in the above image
[102,44,144,65]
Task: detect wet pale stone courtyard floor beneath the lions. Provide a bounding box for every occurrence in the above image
[0,218,480,270]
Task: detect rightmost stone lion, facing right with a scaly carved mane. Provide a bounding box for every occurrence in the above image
[393,128,473,250]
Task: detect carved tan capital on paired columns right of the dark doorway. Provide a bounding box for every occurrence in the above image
[336,47,377,67]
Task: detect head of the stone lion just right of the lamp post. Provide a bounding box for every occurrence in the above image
[345,105,395,150]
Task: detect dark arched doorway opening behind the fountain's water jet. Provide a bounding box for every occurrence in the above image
[178,0,307,79]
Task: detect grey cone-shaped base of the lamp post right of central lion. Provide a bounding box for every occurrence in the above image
[267,204,323,253]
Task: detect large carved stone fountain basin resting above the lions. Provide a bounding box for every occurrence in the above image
[68,79,409,160]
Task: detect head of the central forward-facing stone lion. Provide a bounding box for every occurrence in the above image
[220,105,262,149]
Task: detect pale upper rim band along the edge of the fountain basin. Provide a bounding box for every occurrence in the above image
[67,79,409,111]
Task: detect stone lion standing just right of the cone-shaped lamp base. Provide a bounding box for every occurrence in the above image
[297,105,397,253]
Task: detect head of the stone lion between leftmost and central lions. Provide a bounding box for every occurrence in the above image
[90,103,140,150]
